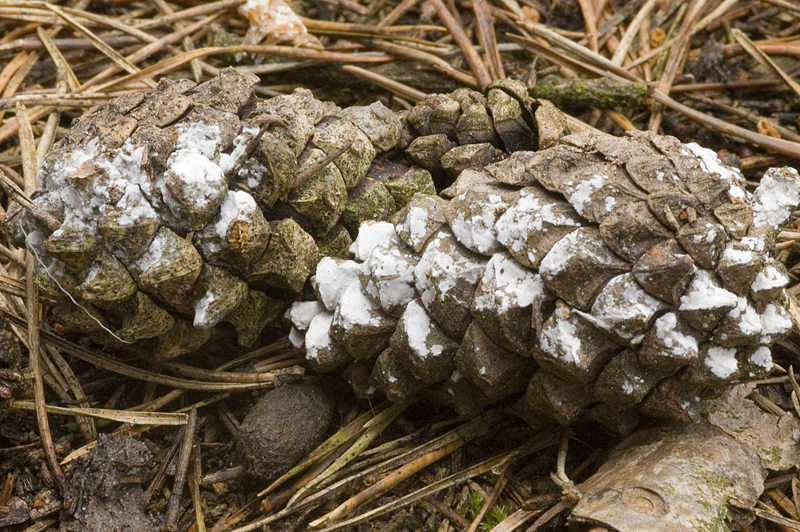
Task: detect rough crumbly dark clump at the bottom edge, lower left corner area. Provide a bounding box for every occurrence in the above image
[63,435,158,532]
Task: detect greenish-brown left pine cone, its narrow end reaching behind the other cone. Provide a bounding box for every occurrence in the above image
[6,69,563,358]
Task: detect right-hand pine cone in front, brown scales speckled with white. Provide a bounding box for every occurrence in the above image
[290,131,800,432]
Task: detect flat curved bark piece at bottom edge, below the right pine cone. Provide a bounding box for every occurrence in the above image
[570,423,767,532]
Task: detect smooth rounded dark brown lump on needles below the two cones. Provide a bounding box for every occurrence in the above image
[236,377,336,481]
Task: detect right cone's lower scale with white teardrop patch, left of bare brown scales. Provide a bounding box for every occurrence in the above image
[389,300,458,386]
